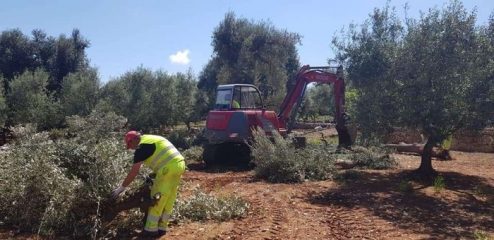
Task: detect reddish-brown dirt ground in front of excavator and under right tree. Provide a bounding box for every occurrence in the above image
[162,152,494,239]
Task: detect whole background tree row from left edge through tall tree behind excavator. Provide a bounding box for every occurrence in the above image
[0,13,300,130]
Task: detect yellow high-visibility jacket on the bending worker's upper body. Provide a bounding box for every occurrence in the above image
[139,134,184,173]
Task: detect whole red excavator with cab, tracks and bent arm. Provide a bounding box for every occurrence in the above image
[203,65,352,165]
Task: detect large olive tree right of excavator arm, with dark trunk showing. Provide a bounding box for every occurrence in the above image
[333,1,494,176]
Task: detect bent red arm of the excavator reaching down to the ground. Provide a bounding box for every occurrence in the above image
[278,65,352,147]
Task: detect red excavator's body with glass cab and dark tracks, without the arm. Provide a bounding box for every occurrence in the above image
[203,84,279,165]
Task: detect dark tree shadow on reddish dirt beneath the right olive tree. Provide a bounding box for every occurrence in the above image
[308,171,494,239]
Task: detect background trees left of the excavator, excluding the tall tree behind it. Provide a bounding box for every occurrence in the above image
[0,29,203,130]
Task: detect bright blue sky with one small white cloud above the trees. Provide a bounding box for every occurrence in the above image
[0,0,494,83]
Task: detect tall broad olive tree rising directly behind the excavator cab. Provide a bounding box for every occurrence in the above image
[199,12,301,106]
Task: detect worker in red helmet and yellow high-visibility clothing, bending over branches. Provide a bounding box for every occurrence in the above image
[113,131,185,237]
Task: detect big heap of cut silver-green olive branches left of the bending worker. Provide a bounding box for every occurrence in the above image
[0,113,133,237]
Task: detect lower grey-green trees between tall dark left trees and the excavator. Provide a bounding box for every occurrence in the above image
[98,67,196,130]
